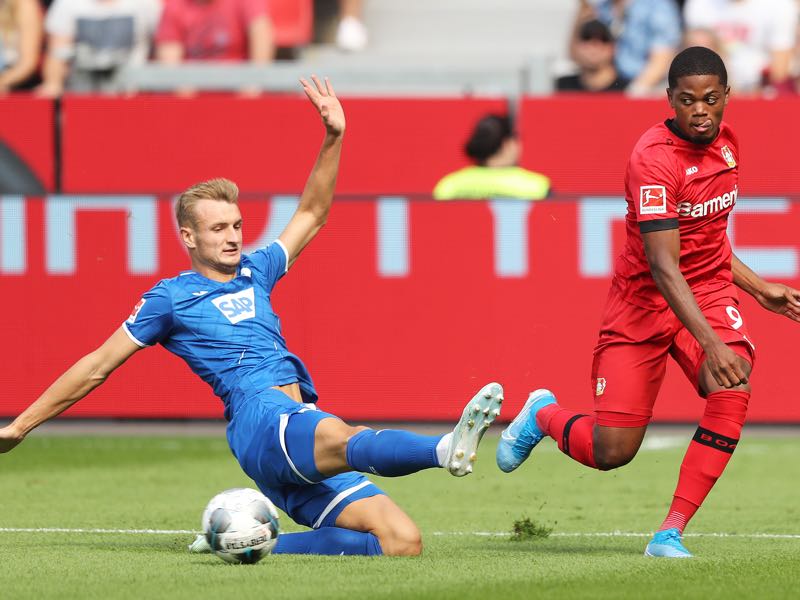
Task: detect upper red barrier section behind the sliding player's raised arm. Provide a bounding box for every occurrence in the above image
[63,95,506,194]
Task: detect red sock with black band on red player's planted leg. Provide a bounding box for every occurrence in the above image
[660,390,750,533]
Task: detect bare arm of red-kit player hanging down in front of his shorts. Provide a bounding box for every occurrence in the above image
[642,229,747,388]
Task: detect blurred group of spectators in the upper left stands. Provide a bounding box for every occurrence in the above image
[0,0,367,97]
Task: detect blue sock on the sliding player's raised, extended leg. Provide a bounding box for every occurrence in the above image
[347,429,443,477]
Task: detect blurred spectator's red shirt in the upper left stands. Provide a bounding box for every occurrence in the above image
[156,0,268,60]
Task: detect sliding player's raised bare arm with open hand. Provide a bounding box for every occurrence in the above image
[278,75,345,267]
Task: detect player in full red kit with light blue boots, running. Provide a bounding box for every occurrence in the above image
[497,47,800,558]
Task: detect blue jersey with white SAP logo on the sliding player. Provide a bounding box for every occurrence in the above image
[123,241,317,419]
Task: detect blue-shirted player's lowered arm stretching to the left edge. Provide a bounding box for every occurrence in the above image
[0,327,140,453]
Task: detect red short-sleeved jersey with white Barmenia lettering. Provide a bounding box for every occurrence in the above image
[614,122,739,308]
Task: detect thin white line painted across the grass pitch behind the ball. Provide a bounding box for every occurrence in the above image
[0,527,800,540]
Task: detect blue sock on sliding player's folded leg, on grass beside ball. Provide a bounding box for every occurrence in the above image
[272,527,383,556]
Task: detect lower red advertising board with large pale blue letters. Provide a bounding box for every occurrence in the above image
[0,194,800,421]
